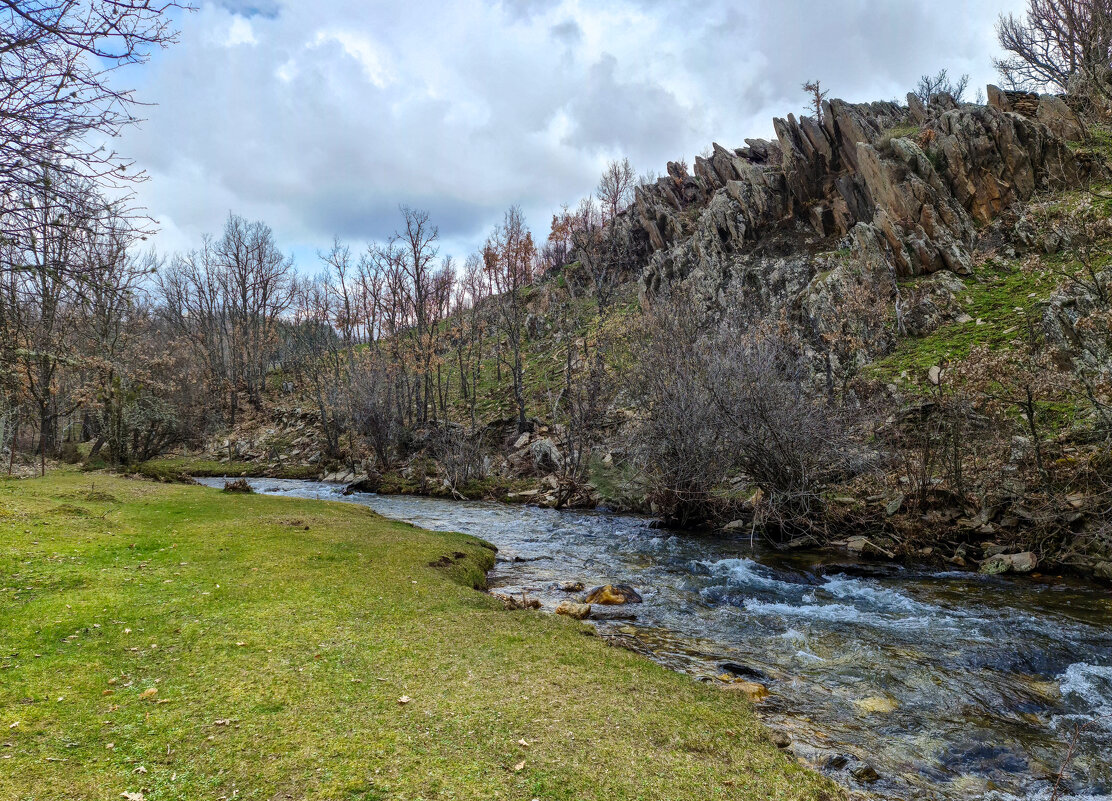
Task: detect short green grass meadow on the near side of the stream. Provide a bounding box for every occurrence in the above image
[0,472,838,801]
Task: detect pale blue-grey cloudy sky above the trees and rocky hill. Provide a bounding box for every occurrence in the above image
[120,0,1022,271]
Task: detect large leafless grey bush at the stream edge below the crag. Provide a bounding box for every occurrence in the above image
[633,296,872,534]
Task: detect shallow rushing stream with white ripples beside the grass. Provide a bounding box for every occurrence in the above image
[206,479,1112,801]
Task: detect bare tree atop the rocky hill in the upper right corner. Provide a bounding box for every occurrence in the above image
[994,0,1112,96]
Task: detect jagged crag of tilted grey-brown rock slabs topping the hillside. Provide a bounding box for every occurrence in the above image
[627,88,1086,318]
